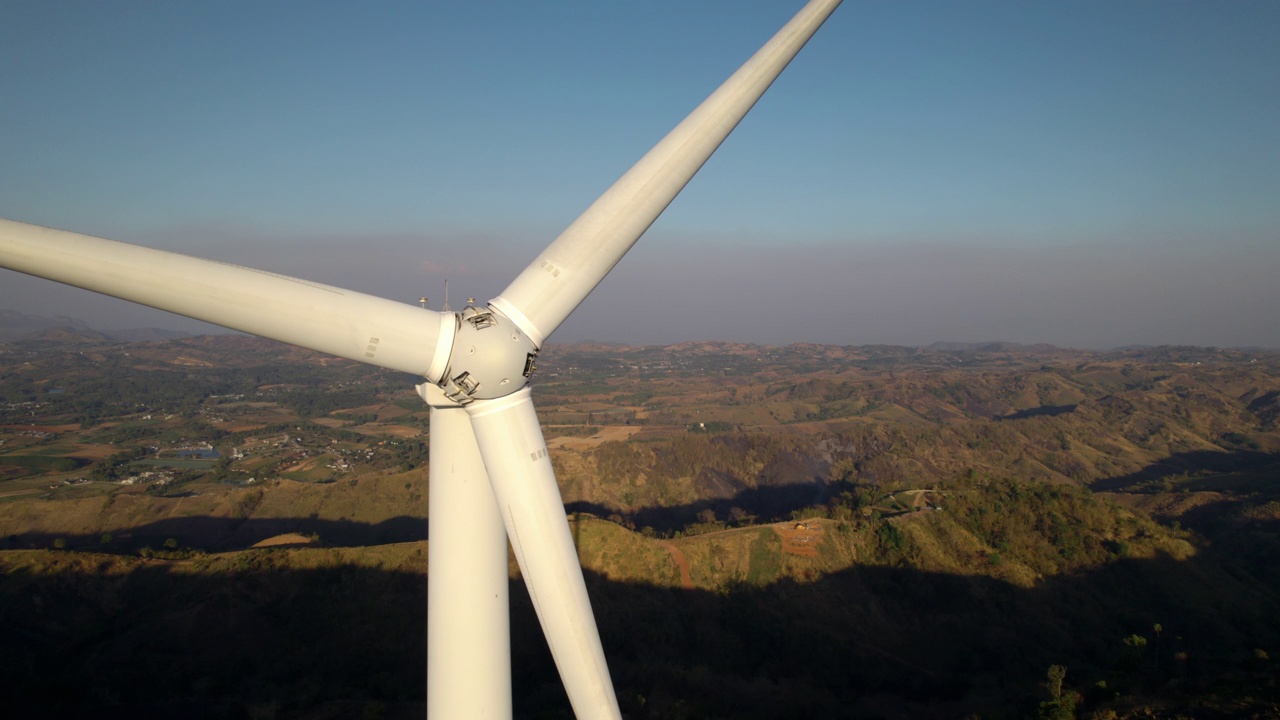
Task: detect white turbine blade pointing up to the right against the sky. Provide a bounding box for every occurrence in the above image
[490,0,840,346]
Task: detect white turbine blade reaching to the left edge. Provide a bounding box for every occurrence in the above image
[0,219,456,380]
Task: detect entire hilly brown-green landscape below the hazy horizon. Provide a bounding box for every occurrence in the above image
[0,338,1280,719]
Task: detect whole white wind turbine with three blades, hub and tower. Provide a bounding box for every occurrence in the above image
[0,0,840,720]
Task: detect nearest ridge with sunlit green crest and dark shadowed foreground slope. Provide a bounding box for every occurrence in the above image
[0,478,1280,717]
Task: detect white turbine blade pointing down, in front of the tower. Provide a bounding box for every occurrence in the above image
[466,388,621,720]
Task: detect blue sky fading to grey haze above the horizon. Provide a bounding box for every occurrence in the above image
[0,0,1280,347]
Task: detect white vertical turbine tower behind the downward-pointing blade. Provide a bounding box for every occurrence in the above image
[419,383,511,719]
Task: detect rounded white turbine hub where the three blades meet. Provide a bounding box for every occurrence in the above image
[440,305,538,405]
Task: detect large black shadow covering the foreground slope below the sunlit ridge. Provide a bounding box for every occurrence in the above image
[0,525,1280,719]
